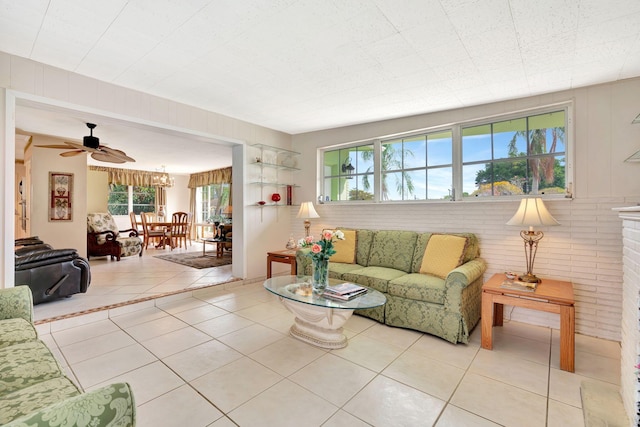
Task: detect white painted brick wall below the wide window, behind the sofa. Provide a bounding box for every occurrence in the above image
[291,197,638,341]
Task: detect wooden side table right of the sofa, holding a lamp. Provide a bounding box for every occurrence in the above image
[482,274,576,372]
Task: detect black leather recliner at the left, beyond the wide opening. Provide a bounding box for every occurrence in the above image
[15,241,91,305]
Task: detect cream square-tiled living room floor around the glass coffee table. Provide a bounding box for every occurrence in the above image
[31,246,620,427]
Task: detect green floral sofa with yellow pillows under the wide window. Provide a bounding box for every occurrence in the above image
[296,228,487,343]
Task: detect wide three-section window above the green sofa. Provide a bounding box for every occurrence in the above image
[323,107,568,201]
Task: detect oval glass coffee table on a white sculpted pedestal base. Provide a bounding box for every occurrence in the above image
[264,276,387,349]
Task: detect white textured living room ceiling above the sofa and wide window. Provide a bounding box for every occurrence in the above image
[0,0,640,170]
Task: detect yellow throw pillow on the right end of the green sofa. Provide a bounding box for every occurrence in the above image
[420,234,467,279]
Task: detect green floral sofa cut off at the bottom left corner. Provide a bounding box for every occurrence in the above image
[0,286,135,427]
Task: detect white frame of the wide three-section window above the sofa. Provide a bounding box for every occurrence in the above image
[318,102,575,204]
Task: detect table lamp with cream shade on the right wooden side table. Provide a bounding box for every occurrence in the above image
[507,197,560,283]
